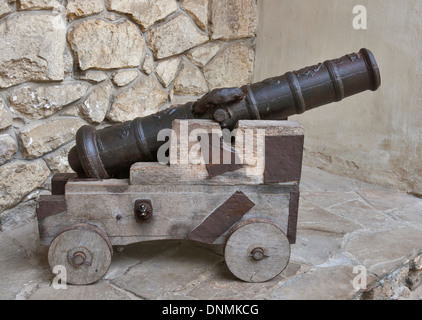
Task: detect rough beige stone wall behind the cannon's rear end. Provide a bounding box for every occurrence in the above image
[0,0,257,229]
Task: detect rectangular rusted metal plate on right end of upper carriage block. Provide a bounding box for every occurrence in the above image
[264,135,304,184]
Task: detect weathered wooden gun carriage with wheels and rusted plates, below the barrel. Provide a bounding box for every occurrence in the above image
[37,120,304,285]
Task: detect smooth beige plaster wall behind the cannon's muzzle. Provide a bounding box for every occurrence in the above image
[253,0,422,194]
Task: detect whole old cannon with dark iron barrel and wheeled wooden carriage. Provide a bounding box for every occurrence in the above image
[37,49,381,285]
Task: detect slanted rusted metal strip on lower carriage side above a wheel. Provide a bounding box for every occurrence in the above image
[187,191,255,244]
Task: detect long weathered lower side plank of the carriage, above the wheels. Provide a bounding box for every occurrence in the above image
[39,180,294,245]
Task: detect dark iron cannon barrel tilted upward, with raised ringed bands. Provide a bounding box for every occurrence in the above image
[68,49,381,179]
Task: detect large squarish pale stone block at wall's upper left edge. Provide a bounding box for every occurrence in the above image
[0,13,66,88]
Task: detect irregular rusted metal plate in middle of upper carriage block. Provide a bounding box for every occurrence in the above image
[201,133,243,178]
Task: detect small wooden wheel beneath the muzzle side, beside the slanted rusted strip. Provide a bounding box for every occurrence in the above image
[224,219,290,282]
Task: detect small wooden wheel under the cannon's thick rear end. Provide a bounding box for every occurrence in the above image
[48,224,113,285]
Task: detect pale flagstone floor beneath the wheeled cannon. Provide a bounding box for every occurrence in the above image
[0,167,422,300]
